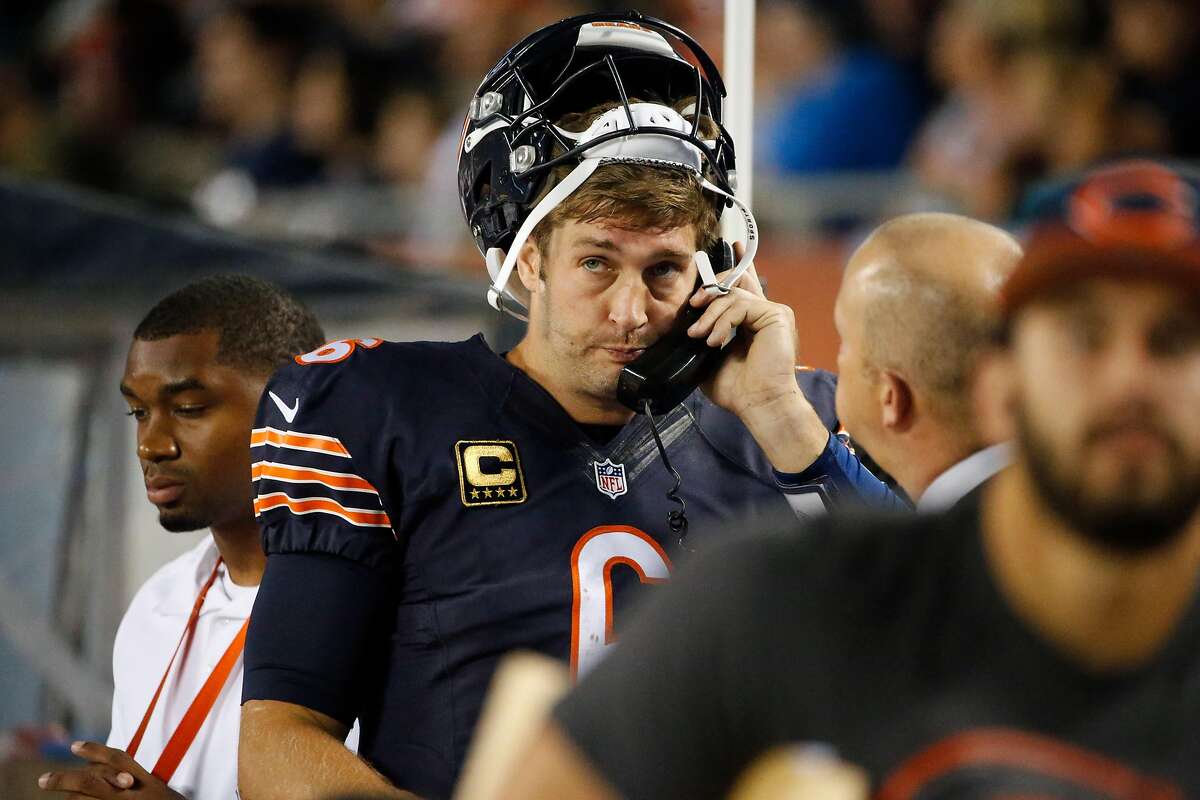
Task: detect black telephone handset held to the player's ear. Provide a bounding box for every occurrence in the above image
[617,240,733,415]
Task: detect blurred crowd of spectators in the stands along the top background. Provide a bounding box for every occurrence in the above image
[0,0,1200,257]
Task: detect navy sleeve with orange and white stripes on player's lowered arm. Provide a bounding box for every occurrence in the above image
[242,339,402,724]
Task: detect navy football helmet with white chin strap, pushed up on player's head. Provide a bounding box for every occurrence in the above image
[458,12,756,317]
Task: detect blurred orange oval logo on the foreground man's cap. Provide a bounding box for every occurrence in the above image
[1067,162,1196,248]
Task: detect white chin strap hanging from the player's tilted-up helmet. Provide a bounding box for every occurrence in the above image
[485,103,758,321]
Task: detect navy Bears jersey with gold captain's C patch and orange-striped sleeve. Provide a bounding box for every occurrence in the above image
[244,337,892,798]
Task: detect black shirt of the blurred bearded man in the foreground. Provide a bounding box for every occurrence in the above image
[556,500,1200,800]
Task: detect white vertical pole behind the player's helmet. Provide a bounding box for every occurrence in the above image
[721,0,755,205]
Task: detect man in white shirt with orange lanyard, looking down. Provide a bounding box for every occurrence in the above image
[38,275,324,800]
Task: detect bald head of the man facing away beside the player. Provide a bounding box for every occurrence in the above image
[835,213,1021,491]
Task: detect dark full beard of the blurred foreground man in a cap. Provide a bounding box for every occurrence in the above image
[1016,407,1200,555]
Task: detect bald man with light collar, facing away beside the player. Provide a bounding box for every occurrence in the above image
[834,213,1021,511]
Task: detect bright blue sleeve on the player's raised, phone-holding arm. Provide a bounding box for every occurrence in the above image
[775,435,911,513]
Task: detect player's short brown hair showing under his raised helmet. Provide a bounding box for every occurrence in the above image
[529,100,718,257]
